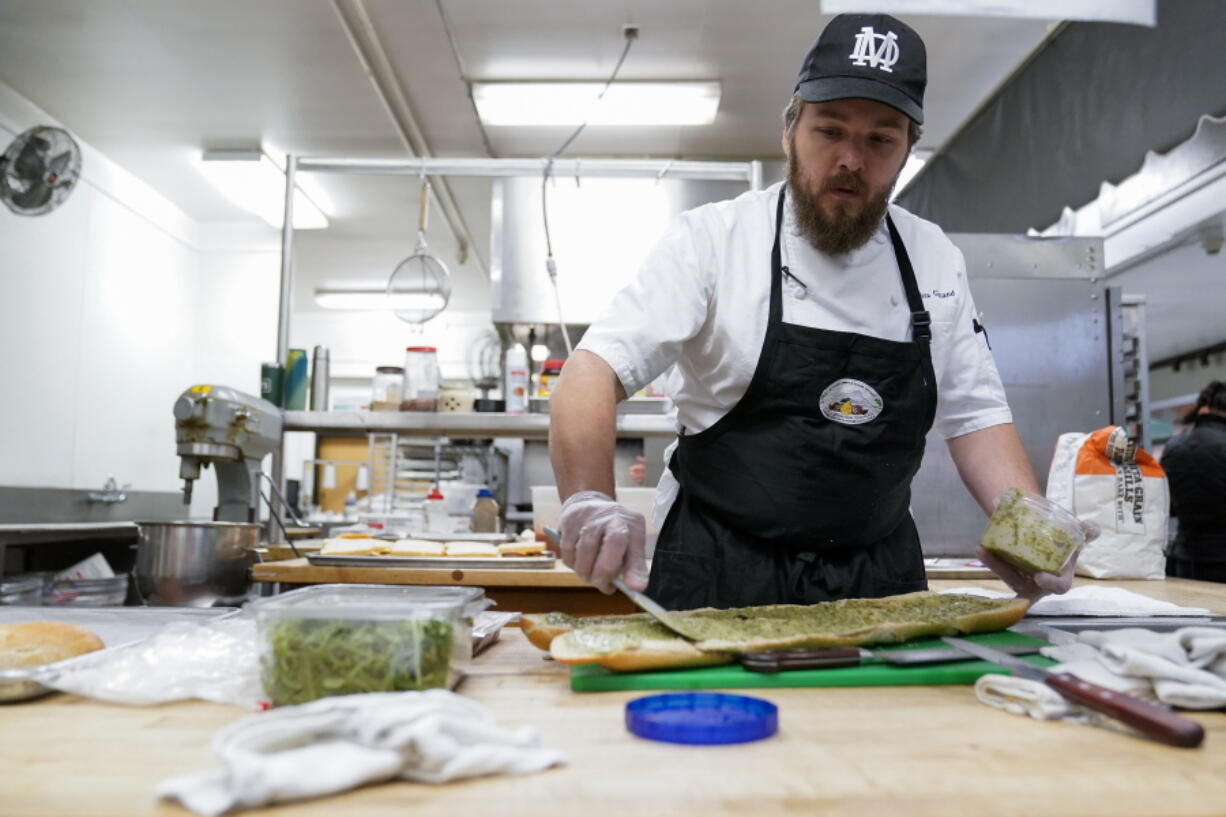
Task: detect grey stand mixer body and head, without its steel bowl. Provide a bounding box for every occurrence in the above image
[174,385,281,523]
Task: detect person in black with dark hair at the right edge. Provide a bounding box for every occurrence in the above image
[1161,380,1226,581]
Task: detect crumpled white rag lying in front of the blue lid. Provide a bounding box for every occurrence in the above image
[157,689,566,817]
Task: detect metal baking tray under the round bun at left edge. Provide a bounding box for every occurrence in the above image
[0,606,238,702]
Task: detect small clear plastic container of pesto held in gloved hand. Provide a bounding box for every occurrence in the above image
[980,488,1085,574]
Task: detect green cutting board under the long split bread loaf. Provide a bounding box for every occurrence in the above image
[570,631,1054,692]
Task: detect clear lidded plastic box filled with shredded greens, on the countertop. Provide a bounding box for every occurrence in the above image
[251,584,490,707]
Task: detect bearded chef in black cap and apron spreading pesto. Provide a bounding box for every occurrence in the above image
[549,15,1072,610]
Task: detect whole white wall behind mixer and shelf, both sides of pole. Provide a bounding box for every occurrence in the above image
[0,83,492,516]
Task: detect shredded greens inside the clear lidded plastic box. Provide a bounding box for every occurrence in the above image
[262,618,452,707]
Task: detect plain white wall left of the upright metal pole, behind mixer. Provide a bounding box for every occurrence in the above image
[0,85,278,515]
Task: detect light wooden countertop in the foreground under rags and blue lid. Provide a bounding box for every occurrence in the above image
[0,580,1226,817]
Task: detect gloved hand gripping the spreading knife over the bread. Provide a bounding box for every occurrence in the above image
[558,491,647,593]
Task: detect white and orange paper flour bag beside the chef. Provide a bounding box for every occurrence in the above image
[1047,426,1171,579]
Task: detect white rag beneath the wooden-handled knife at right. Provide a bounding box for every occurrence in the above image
[975,627,1226,721]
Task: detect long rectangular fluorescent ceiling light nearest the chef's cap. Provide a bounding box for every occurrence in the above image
[472,81,720,125]
